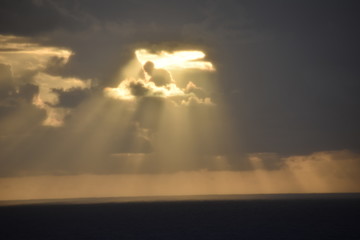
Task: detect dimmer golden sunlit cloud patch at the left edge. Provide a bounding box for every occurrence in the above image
[0,35,91,127]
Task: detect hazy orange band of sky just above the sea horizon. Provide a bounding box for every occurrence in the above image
[0,151,360,200]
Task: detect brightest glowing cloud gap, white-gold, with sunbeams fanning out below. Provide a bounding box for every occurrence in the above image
[104,49,215,105]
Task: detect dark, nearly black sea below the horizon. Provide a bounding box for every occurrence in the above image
[0,194,360,240]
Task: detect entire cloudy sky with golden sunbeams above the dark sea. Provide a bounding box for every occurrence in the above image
[0,0,360,200]
